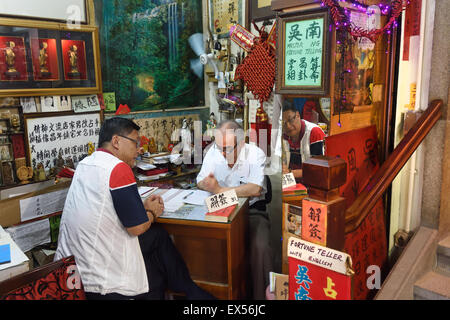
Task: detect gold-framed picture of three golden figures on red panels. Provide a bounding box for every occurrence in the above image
[0,18,101,97]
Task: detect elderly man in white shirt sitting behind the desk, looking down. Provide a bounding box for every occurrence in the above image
[197,120,273,300]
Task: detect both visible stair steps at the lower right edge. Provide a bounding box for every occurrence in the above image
[413,235,450,300]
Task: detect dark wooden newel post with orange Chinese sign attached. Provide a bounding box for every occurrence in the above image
[302,156,347,251]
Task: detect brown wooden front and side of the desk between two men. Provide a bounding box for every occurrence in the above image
[157,199,249,300]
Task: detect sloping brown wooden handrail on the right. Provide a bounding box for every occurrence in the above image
[345,100,443,233]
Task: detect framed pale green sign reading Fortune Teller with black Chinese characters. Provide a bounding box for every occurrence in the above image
[276,10,330,95]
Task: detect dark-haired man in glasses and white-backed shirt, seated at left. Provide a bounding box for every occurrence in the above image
[55,118,213,300]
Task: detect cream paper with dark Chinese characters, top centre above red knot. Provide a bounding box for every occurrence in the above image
[209,0,243,38]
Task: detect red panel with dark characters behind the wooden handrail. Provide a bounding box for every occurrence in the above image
[325,126,387,300]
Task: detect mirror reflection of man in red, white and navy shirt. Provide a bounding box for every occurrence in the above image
[283,100,325,182]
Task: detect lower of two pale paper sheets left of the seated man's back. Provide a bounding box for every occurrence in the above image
[6,219,51,252]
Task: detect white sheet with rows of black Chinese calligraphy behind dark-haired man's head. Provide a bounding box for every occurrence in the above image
[25,112,101,171]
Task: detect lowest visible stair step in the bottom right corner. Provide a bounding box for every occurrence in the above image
[414,271,450,300]
